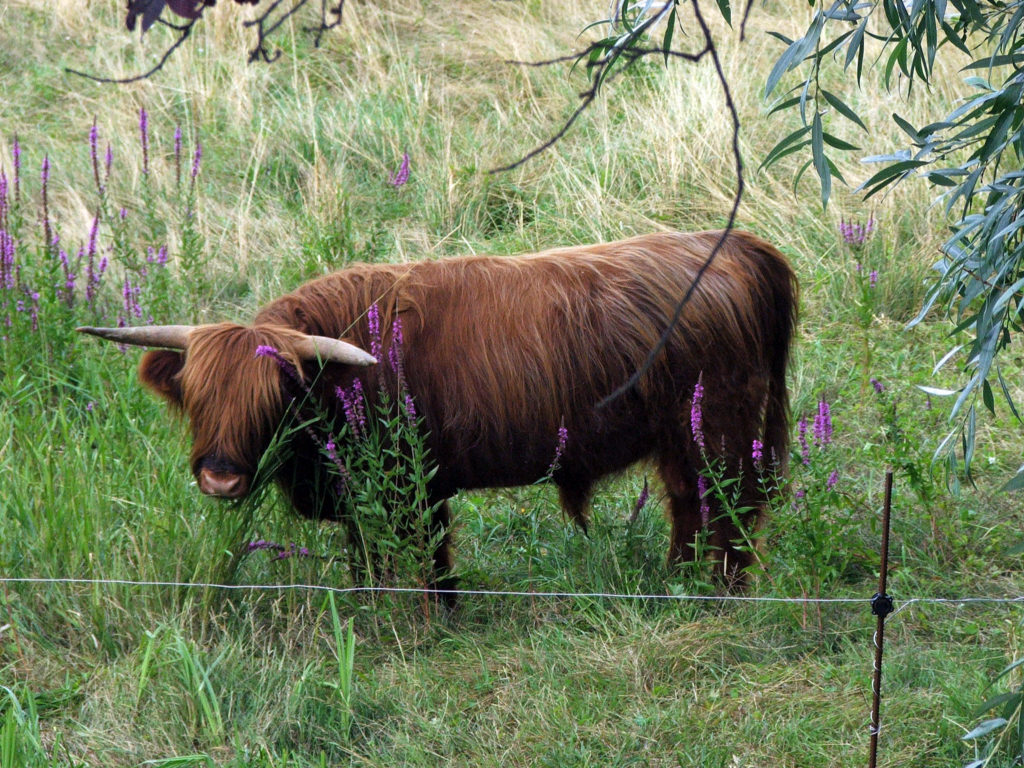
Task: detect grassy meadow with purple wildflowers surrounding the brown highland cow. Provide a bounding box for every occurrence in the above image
[0,0,1024,768]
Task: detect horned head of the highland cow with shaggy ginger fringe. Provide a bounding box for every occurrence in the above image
[78,323,377,499]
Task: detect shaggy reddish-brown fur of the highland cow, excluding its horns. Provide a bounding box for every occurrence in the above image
[140,232,797,589]
